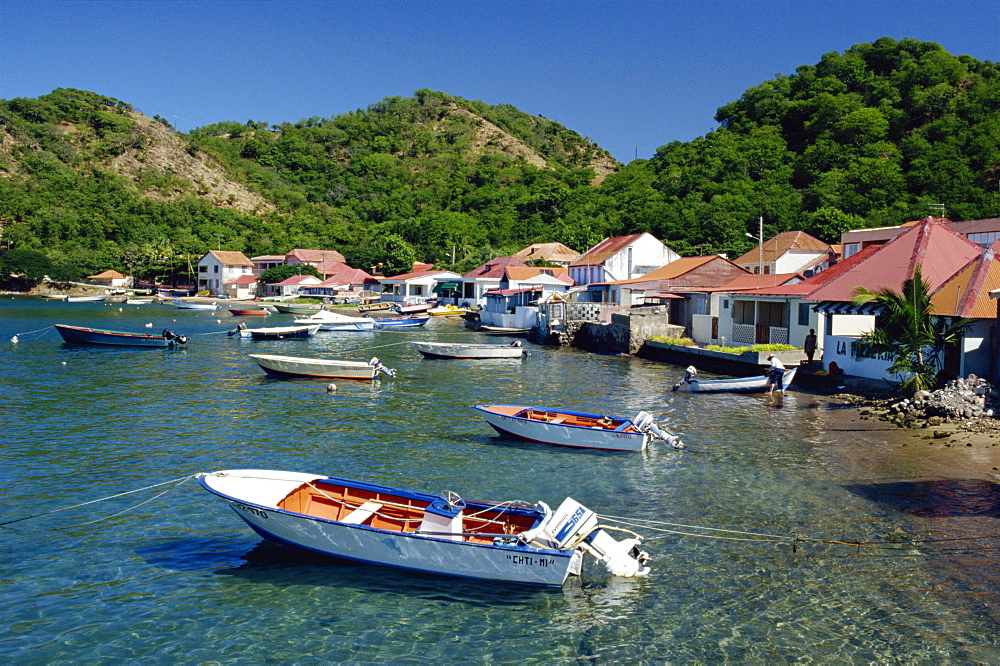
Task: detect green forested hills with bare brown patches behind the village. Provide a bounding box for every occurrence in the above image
[0,38,1000,284]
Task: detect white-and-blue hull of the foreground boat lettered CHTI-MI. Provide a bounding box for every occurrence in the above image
[199,470,581,586]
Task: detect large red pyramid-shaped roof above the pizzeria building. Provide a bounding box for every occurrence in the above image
[809,220,982,301]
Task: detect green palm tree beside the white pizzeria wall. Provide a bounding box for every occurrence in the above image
[854,266,972,394]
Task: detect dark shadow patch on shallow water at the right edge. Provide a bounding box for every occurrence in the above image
[844,479,1000,518]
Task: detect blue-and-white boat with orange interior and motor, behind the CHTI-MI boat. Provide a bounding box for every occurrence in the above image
[476,405,684,451]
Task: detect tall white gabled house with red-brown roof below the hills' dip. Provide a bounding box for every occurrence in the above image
[569,233,681,285]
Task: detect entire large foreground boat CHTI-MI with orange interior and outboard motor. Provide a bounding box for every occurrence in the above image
[198,469,649,586]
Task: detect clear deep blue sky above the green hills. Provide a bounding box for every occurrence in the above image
[0,0,1000,162]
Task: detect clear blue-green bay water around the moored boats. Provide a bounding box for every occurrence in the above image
[0,296,1000,663]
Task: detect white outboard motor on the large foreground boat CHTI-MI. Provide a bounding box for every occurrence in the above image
[540,497,649,578]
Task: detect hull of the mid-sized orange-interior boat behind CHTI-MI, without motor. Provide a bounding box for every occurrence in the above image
[476,405,651,452]
